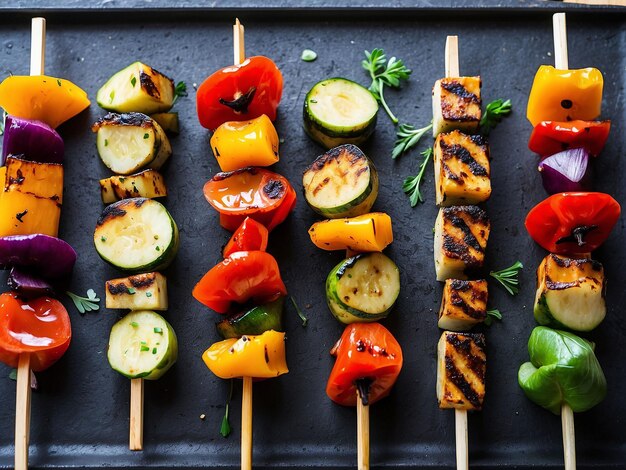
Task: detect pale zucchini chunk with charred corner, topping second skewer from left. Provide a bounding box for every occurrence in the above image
[96,62,175,114]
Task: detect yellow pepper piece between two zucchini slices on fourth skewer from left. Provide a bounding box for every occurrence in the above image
[309,212,393,253]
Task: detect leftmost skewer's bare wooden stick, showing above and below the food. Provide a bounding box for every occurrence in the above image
[15,18,46,470]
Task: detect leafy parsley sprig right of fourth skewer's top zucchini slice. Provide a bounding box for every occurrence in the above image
[361,48,411,124]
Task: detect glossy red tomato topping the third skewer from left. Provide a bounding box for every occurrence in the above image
[196,56,283,130]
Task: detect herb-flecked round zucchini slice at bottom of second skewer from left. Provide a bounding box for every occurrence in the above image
[107,310,178,380]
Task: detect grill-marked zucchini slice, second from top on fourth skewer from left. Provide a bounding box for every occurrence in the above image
[302,144,378,219]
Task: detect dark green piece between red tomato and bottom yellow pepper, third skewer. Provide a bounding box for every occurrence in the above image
[216,297,285,339]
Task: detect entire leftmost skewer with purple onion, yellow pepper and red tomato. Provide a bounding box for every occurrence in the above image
[0,18,89,470]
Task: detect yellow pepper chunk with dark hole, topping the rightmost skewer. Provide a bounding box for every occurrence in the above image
[526,65,604,126]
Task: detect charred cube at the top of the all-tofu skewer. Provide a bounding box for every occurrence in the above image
[433,77,482,137]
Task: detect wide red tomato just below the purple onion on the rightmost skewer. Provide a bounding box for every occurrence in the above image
[526,193,621,255]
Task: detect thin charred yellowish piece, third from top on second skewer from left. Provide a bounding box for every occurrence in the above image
[100,170,167,204]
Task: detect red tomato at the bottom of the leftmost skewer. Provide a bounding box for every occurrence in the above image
[0,292,72,372]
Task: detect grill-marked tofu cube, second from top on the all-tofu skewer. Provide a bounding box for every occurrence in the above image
[434,130,491,206]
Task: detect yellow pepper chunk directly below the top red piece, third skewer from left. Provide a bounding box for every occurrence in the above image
[211,114,279,171]
